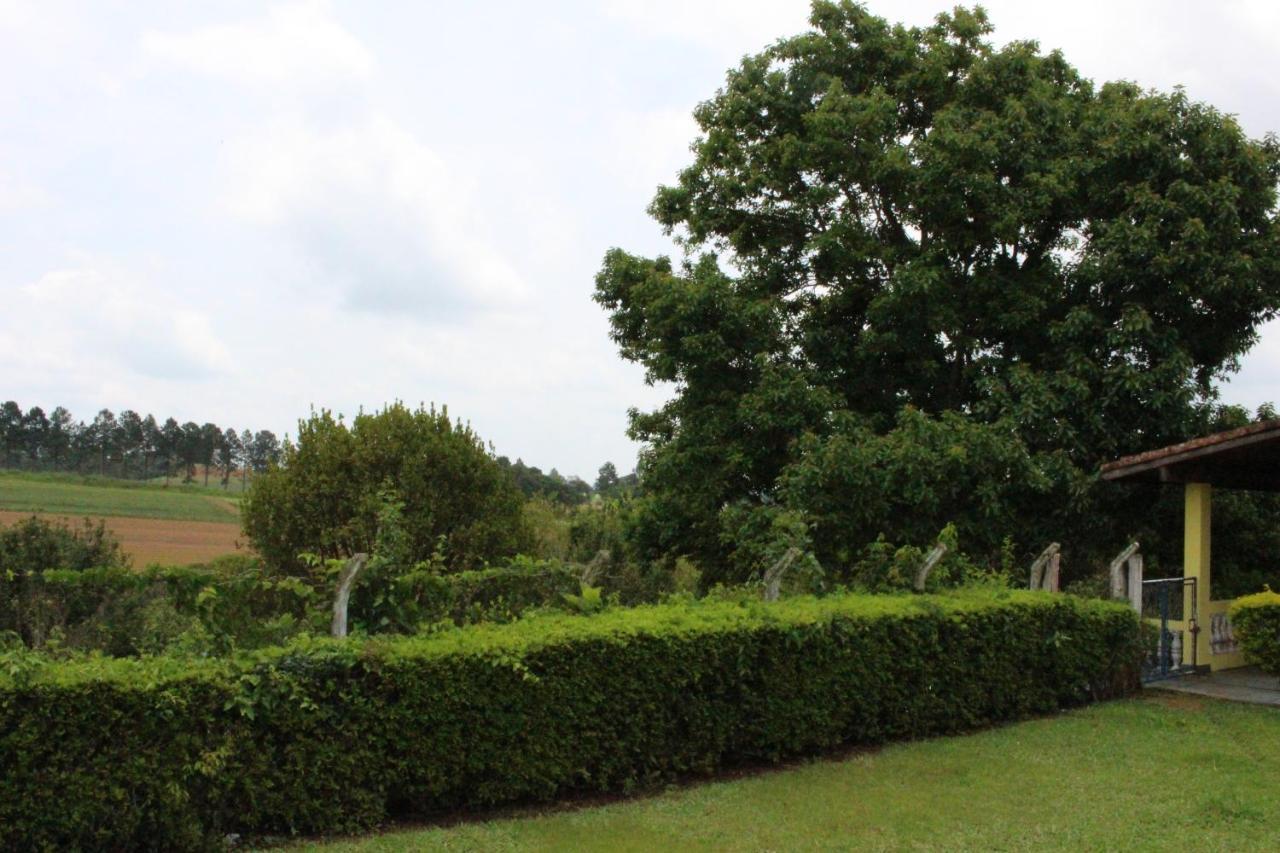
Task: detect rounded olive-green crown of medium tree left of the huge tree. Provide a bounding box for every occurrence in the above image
[242,403,529,571]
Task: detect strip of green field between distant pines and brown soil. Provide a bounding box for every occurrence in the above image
[0,471,239,523]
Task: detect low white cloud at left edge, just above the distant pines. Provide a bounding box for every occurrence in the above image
[0,263,233,387]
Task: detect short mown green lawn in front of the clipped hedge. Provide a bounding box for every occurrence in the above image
[293,692,1280,853]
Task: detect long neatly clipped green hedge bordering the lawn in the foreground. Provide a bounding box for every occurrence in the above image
[0,592,1140,849]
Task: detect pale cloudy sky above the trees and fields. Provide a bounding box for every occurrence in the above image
[0,0,1280,479]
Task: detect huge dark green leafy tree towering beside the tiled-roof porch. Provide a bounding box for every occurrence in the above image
[596,3,1280,578]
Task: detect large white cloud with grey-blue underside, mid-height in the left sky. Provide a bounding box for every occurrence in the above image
[223,115,527,312]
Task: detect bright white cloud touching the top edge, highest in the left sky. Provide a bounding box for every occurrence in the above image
[142,3,374,86]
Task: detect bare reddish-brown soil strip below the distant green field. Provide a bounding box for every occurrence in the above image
[0,510,248,567]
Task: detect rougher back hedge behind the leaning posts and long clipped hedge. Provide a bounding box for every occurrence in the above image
[0,557,580,657]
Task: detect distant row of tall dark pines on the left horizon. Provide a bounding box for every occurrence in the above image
[0,400,280,488]
